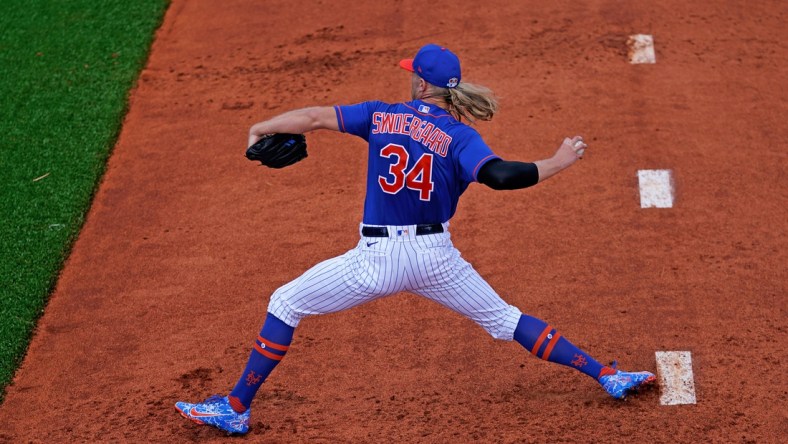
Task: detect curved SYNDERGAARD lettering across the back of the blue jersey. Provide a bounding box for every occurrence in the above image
[372,111,451,157]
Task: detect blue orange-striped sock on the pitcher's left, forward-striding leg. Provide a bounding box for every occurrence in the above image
[227,313,295,413]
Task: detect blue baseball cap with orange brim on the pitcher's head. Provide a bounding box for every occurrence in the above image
[399,43,462,88]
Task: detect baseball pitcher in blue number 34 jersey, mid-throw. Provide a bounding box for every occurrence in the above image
[176,44,656,434]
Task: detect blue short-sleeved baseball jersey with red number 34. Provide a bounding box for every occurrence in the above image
[334,100,498,225]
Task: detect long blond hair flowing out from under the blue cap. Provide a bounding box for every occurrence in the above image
[430,82,498,123]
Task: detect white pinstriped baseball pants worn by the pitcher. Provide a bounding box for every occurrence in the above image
[268,223,521,341]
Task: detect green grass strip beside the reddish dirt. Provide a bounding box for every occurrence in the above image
[0,0,168,401]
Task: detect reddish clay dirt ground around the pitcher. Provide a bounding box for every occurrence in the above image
[0,0,788,442]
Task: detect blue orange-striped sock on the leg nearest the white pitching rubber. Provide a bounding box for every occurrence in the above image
[514,314,615,380]
